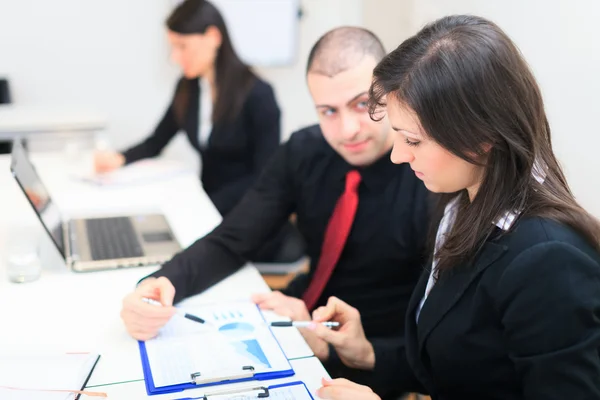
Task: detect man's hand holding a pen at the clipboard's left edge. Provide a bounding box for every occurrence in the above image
[121,277,175,340]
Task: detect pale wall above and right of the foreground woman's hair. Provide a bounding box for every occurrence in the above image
[365,0,600,217]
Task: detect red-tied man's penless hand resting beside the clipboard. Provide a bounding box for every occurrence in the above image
[252,292,329,361]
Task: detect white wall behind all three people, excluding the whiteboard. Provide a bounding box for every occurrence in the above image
[0,0,600,216]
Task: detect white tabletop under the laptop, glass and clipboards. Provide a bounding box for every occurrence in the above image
[0,154,327,399]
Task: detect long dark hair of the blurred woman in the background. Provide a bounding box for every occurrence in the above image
[167,0,256,125]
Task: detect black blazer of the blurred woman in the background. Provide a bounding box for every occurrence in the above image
[123,78,281,215]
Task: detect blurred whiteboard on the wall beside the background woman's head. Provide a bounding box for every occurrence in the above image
[175,0,300,67]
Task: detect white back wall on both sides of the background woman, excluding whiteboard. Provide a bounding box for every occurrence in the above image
[0,0,362,167]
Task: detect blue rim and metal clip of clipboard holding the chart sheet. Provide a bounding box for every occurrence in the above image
[138,306,295,396]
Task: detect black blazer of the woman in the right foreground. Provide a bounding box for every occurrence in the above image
[405,218,600,400]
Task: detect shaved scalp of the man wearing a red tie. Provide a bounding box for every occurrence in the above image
[306,26,386,77]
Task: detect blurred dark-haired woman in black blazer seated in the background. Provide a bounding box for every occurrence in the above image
[94,0,304,262]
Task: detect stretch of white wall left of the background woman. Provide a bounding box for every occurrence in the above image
[0,0,176,154]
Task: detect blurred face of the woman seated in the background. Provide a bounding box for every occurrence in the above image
[167,27,221,79]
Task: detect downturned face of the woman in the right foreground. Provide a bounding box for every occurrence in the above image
[387,99,484,200]
